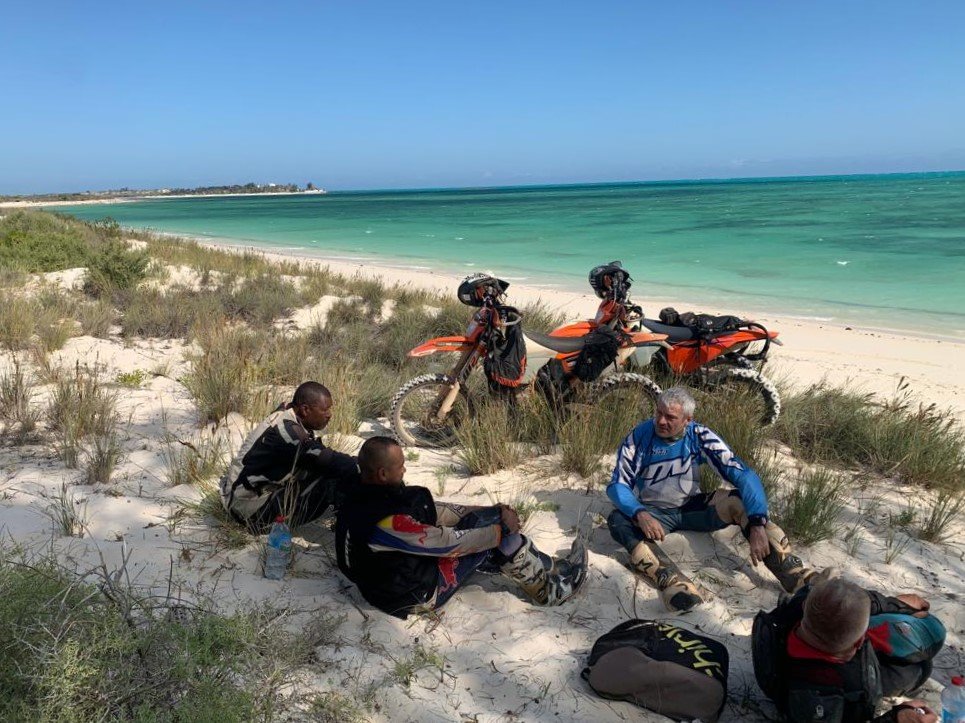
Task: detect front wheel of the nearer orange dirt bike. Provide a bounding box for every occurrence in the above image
[389,374,472,447]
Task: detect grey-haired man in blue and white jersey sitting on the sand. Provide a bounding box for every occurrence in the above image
[606,387,812,612]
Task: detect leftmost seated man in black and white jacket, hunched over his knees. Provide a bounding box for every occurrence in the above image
[221,382,359,532]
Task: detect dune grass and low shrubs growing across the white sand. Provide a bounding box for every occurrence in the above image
[0,212,965,721]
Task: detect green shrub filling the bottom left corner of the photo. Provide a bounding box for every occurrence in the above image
[0,561,314,723]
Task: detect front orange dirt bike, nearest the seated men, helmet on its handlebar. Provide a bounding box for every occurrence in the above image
[389,274,666,447]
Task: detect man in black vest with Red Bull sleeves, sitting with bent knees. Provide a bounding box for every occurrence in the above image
[335,437,586,618]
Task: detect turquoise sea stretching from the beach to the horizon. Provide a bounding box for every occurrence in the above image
[52,172,965,339]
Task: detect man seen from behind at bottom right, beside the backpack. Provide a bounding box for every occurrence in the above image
[752,573,945,723]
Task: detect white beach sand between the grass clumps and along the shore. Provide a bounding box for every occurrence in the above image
[0,245,965,723]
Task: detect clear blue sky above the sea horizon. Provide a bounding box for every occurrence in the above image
[0,0,965,193]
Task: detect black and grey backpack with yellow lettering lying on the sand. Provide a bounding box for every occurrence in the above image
[582,620,729,723]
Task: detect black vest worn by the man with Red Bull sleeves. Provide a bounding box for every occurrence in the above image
[335,484,439,618]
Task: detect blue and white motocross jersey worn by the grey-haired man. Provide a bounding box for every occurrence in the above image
[606,419,767,518]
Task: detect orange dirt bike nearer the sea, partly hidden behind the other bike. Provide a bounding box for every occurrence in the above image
[551,261,781,426]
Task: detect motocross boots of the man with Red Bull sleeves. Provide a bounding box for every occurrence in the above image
[500,536,587,607]
